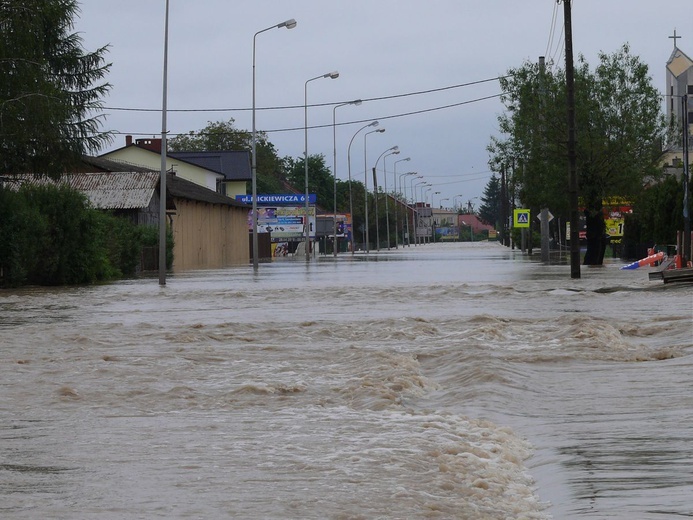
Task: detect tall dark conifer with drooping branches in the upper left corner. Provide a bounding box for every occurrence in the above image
[0,0,111,176]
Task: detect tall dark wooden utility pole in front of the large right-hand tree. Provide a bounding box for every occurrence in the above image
[558,0,580,278]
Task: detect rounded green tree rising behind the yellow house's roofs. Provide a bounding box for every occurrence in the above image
[167,118,285,193]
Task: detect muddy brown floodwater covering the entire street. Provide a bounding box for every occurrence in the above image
[0,243,693,520]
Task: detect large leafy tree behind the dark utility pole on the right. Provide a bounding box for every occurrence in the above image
[489,45,666,265]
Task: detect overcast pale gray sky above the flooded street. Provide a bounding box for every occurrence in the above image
[75,0,693,206]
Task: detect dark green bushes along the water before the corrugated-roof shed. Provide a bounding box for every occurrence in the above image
[0,185,173,286]
